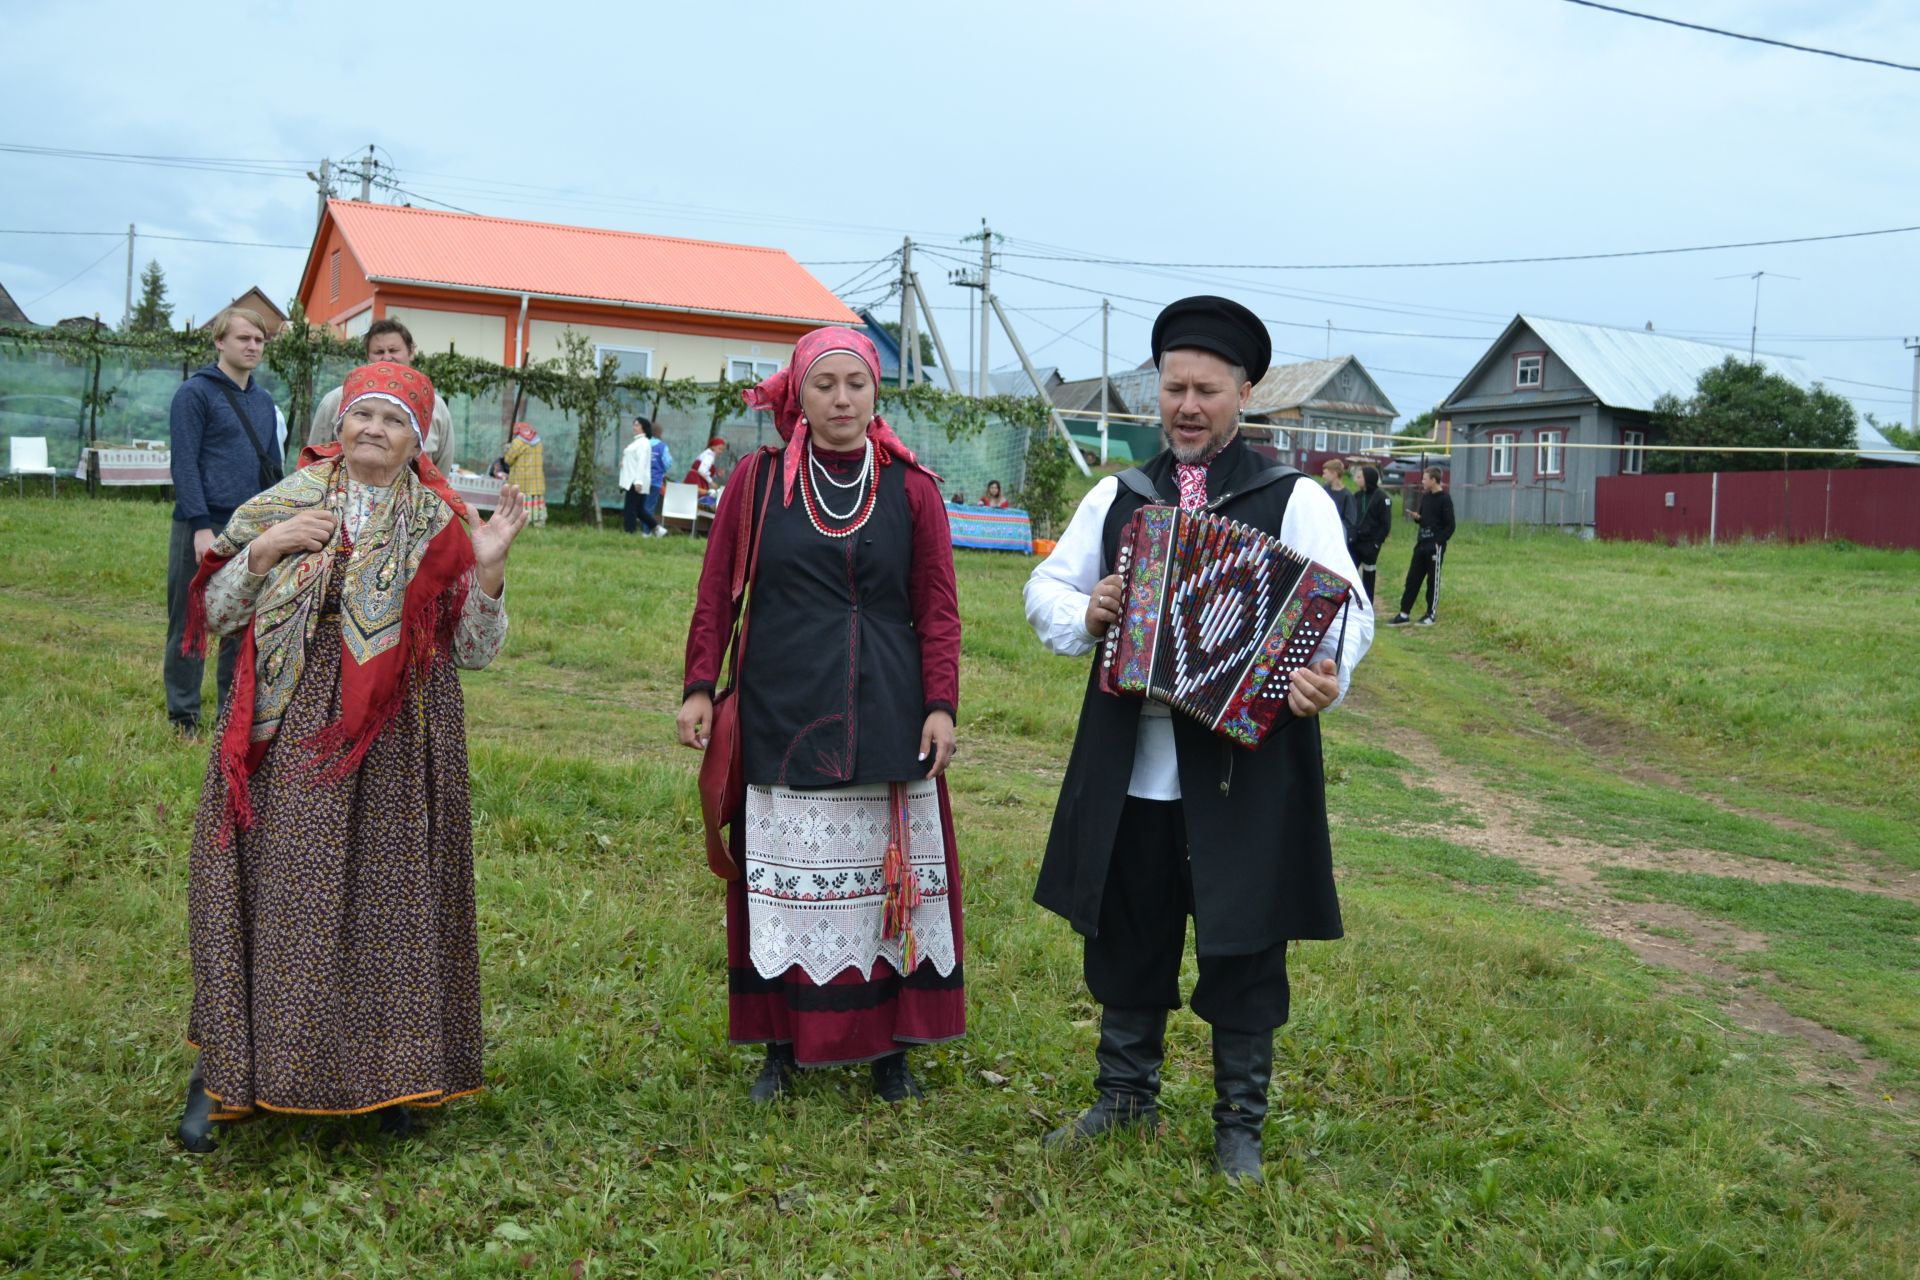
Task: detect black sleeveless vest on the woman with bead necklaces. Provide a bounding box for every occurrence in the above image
[739,455,927,787]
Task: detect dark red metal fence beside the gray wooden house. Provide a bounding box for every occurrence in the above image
[1594,466,1920,549]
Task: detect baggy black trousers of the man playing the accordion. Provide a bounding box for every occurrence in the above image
[1083,796,1288,1032]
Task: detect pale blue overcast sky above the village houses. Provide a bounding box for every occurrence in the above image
[0,0,1920,420]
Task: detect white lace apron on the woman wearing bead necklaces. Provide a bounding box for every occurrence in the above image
[745,779,954,984]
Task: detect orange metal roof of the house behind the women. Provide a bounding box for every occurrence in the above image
[309,200,860,324]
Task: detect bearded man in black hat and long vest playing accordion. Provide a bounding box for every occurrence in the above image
[1025,297,1373,1182]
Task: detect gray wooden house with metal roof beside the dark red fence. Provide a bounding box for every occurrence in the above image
[1436,315,1812,526]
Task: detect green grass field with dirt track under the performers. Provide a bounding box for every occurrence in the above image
[0,499,1920,1280]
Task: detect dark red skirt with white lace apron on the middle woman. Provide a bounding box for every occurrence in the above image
[726,779,966,1067]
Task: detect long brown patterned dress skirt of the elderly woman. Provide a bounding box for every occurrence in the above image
[188,614,482,1119]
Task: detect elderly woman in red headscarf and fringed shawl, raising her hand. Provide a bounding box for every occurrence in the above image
[179,363,526,1151]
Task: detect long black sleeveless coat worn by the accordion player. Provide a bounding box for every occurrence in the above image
[1033,439,1342,956]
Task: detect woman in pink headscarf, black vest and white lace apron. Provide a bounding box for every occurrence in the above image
[678,328,966,1102]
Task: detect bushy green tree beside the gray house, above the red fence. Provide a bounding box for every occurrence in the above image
[1647,355,1855,472]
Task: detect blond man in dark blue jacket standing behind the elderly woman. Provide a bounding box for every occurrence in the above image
[161,307,286,733]
